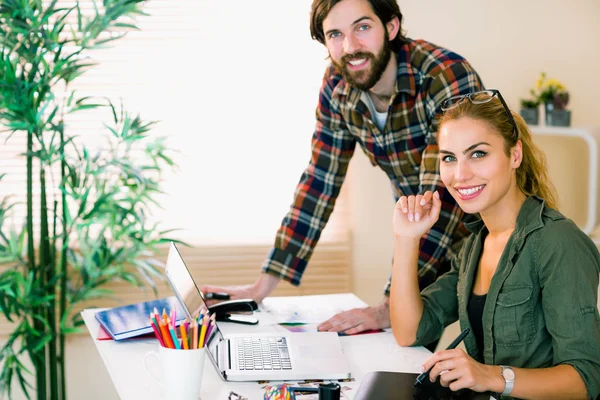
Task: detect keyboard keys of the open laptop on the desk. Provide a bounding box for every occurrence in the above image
[237,337,292,370]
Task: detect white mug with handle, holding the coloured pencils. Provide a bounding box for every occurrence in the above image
[144,346,206,400]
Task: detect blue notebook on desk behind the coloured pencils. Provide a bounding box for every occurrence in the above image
[96,296,185,340]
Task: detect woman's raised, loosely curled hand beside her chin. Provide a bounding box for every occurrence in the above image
[393,191,442,239]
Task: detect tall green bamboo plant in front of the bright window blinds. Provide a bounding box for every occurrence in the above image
[0,0,183,400]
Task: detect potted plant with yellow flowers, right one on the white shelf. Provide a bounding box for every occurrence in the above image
[536,72,571,126]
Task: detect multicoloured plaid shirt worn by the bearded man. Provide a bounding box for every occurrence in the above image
[262,39,483,295]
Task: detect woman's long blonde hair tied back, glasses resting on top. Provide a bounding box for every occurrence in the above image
[439,94,558,208]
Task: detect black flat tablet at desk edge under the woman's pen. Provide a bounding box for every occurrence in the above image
[354,371,490,400]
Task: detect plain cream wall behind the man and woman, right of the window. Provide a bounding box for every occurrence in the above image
[350,0,600,303]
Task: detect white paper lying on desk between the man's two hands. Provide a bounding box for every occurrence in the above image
[259,293,367,324]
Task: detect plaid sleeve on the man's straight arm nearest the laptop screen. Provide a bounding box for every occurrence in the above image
[262,75,356,285]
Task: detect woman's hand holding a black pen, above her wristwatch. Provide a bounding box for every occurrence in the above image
[423,349,504,392]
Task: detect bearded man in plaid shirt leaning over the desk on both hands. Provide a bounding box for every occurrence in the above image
[202,0,483,334]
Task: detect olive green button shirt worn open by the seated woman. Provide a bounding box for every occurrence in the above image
[415,197,600,399]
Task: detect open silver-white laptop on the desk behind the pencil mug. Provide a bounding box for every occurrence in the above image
[165,242,350,381]
